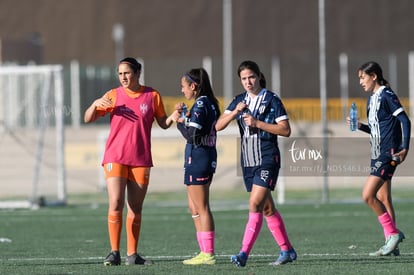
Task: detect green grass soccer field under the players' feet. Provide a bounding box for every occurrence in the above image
[0,191,414,274]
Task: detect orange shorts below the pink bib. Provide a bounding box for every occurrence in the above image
[104,163,151,184]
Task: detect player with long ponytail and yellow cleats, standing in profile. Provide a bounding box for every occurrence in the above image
[176,68,220,265]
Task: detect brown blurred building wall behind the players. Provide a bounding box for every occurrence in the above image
[0,0,414,101]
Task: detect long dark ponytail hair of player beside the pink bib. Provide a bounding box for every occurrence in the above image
[184,68,220,116]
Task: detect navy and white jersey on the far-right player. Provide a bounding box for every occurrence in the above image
[367,86,404,159]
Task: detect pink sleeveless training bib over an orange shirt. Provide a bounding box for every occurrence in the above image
[102,87,154,167]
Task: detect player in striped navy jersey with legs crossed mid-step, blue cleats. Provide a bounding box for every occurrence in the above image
[216,61,297,266]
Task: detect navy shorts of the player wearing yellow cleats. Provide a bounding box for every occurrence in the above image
[184,143,217,185]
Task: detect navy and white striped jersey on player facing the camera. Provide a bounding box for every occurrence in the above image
[225,89,288,167]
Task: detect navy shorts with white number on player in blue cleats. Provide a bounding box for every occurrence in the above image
[242,164,280,192]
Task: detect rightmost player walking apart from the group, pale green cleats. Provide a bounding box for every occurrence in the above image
[347,62,411,256]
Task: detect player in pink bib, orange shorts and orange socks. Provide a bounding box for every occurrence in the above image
[84,57,173,265]
